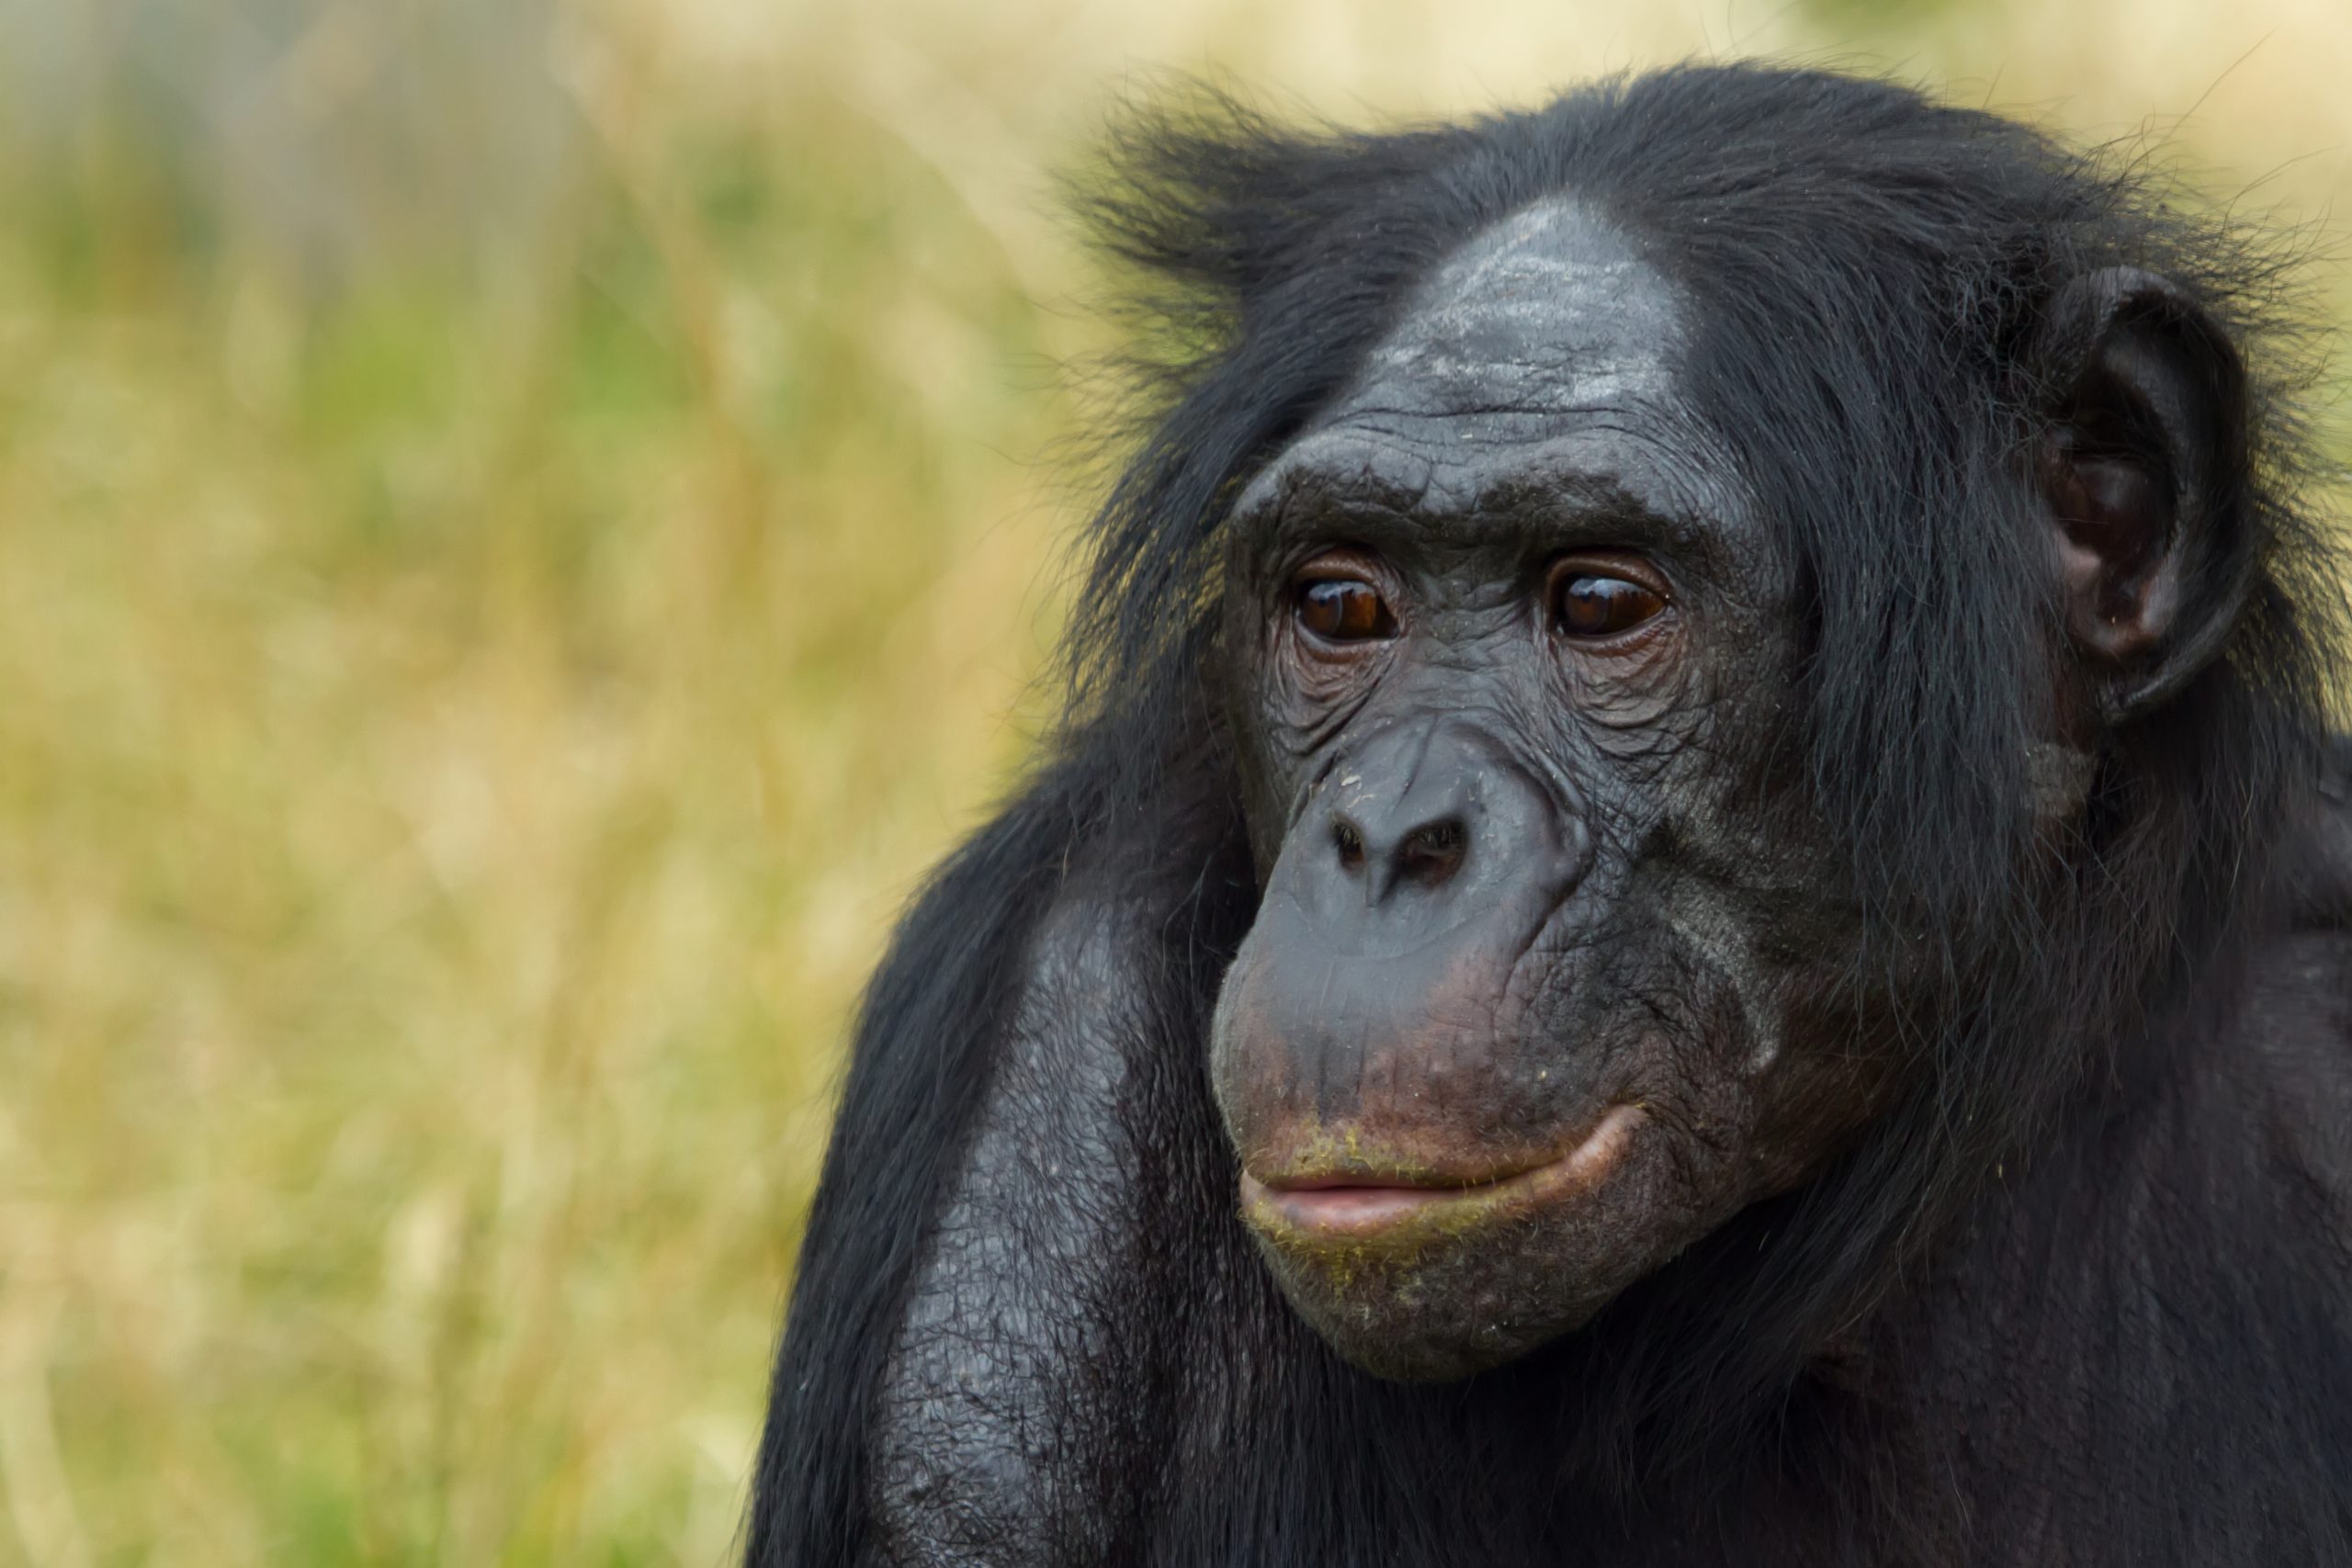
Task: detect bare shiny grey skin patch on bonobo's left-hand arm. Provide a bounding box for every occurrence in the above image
[870,894,1185,1563]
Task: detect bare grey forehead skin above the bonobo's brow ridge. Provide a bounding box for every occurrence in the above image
[1238,197,1726,540]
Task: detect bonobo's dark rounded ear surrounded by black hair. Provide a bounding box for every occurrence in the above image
[2032,265,2256,722]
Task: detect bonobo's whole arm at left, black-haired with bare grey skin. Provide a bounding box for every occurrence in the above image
[748,781,1230,1568]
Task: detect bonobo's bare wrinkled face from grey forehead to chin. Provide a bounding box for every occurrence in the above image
[1211,202,1886,1380]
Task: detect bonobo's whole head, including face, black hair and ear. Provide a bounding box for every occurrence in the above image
[1114,73,2333,1378]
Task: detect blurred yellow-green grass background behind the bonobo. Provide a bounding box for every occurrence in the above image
[0,0,2352,1568]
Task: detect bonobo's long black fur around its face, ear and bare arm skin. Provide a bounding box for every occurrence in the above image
[748,66,2352,1565]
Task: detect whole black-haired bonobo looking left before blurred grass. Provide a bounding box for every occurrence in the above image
[751,66,2352,1568]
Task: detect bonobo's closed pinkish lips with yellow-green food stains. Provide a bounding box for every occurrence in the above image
[1242,1102,1646,1248]
